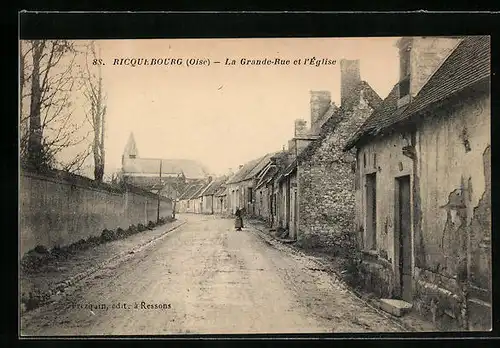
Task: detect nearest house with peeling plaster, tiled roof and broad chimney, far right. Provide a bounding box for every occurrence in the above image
[345,36,492,330]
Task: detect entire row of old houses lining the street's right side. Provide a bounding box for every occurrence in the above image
[180,36,492,330]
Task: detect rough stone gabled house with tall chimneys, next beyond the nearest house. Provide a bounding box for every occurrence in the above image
[279,60,381,242]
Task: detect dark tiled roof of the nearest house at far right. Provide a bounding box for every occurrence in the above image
[345,36,491,150]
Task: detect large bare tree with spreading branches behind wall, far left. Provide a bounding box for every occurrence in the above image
[20,40,92,171]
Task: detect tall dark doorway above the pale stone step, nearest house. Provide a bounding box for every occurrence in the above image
[394,175,413,302]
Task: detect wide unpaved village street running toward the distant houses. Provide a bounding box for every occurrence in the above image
[21,215,403,336]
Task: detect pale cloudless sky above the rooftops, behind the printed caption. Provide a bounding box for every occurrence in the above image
[54,38,399,175]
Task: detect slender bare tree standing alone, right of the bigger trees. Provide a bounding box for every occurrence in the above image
[84,41,106,182]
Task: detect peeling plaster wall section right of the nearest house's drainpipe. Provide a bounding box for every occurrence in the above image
[415,95,492,329]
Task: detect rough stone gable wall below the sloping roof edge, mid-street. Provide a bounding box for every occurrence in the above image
[297,105,372,248]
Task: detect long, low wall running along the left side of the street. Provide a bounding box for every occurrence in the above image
[19,169,172,255]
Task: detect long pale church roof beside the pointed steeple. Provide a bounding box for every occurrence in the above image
[123,158,207,179]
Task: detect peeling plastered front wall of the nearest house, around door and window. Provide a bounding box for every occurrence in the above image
[356,92,492,329]
